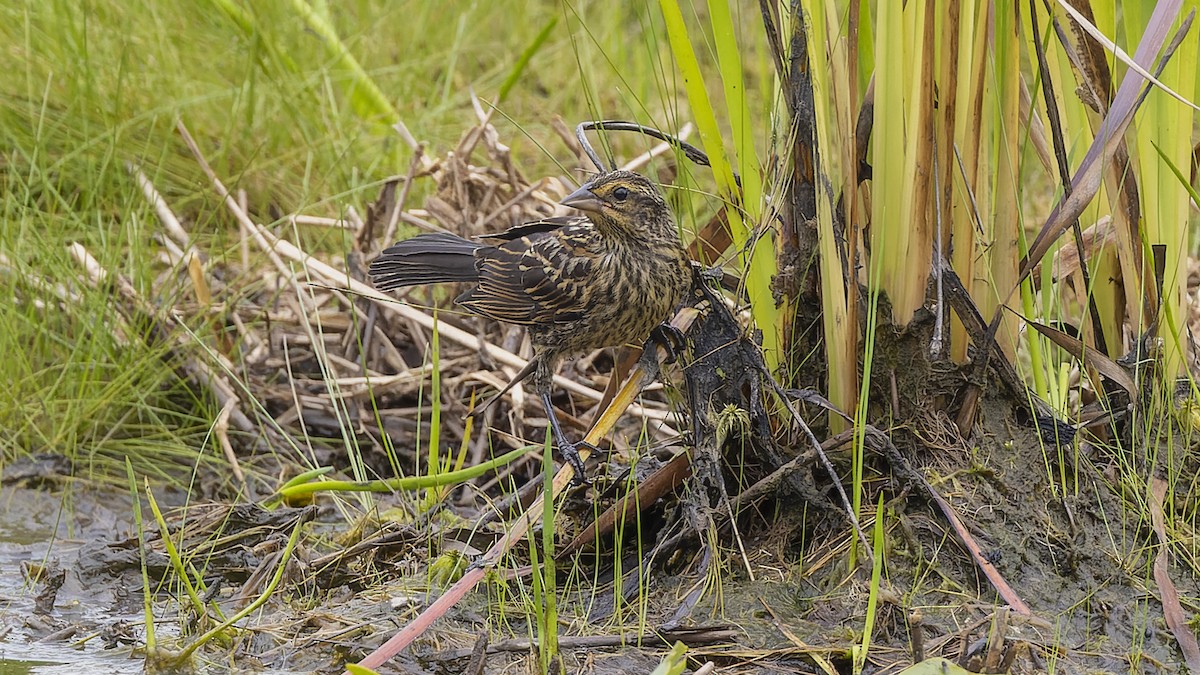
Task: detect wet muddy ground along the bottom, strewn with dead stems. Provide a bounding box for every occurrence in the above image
[0,343,1200,673]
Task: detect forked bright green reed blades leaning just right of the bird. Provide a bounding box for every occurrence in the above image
[659,0,782,370]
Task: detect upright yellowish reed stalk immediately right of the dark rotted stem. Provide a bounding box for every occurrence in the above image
[806,0,858,432]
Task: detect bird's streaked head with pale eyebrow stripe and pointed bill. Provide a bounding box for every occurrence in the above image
[562,171,679,245]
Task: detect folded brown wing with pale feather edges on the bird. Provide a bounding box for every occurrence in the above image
[458,221,600,325]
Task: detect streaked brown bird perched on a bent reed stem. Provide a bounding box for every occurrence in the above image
[371,171,691,482]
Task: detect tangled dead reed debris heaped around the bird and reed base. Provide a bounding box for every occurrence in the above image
[32,112,1195,671]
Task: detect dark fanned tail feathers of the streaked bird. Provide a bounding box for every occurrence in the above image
[371,232,484,291]
